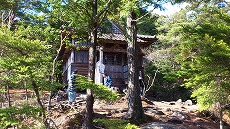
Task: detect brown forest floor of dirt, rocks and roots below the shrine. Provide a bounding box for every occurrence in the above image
[3,90,230,129]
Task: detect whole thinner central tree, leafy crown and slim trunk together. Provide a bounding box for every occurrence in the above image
[47,0,119,129]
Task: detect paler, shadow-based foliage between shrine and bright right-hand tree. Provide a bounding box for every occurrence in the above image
[145,10,191,101]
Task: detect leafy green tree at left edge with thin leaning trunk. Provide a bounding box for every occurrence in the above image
[0,0,60,127]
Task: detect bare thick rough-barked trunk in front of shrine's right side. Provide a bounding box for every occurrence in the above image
[126,11,144,122]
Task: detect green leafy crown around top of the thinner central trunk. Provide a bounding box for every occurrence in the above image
[46,0,120,39]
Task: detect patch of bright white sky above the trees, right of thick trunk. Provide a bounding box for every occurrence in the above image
[148,3,188,17]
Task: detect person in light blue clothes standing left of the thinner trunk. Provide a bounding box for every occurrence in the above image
[68,70,77,104]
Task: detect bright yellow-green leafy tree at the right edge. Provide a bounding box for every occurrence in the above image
[174,6,230,110]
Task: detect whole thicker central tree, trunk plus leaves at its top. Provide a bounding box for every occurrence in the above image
[121,0,167,122]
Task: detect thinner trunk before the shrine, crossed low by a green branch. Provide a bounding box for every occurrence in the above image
[83,0,97,129]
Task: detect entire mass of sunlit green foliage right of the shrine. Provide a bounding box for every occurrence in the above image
[146,4,230,107]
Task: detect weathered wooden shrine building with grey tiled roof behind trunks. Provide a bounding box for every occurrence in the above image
[60,20,157,89]
